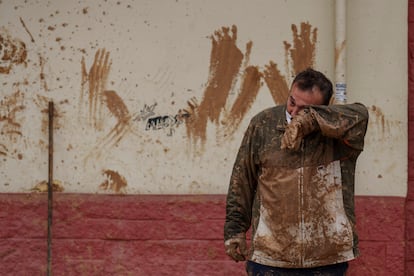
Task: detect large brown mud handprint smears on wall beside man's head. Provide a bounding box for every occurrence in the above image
[186,22,317,150]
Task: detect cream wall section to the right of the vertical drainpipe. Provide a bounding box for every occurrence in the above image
[347,0,408,196]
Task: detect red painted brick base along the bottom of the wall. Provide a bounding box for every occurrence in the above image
[0,194,405,276]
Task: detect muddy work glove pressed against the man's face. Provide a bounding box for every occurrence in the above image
[280,109,318,151]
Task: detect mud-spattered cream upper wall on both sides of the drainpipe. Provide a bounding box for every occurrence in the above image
[0,0,407,195]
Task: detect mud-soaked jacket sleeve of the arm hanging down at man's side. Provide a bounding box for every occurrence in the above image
[224,119,257,240]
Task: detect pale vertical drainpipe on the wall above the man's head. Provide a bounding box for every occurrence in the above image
[334,0,346,104]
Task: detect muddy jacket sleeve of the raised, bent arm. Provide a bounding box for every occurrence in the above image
[309,103,368,151]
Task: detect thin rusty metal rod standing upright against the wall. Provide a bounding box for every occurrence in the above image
[47,102,54,276]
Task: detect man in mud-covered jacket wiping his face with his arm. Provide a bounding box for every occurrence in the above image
[224,69,368,276]
